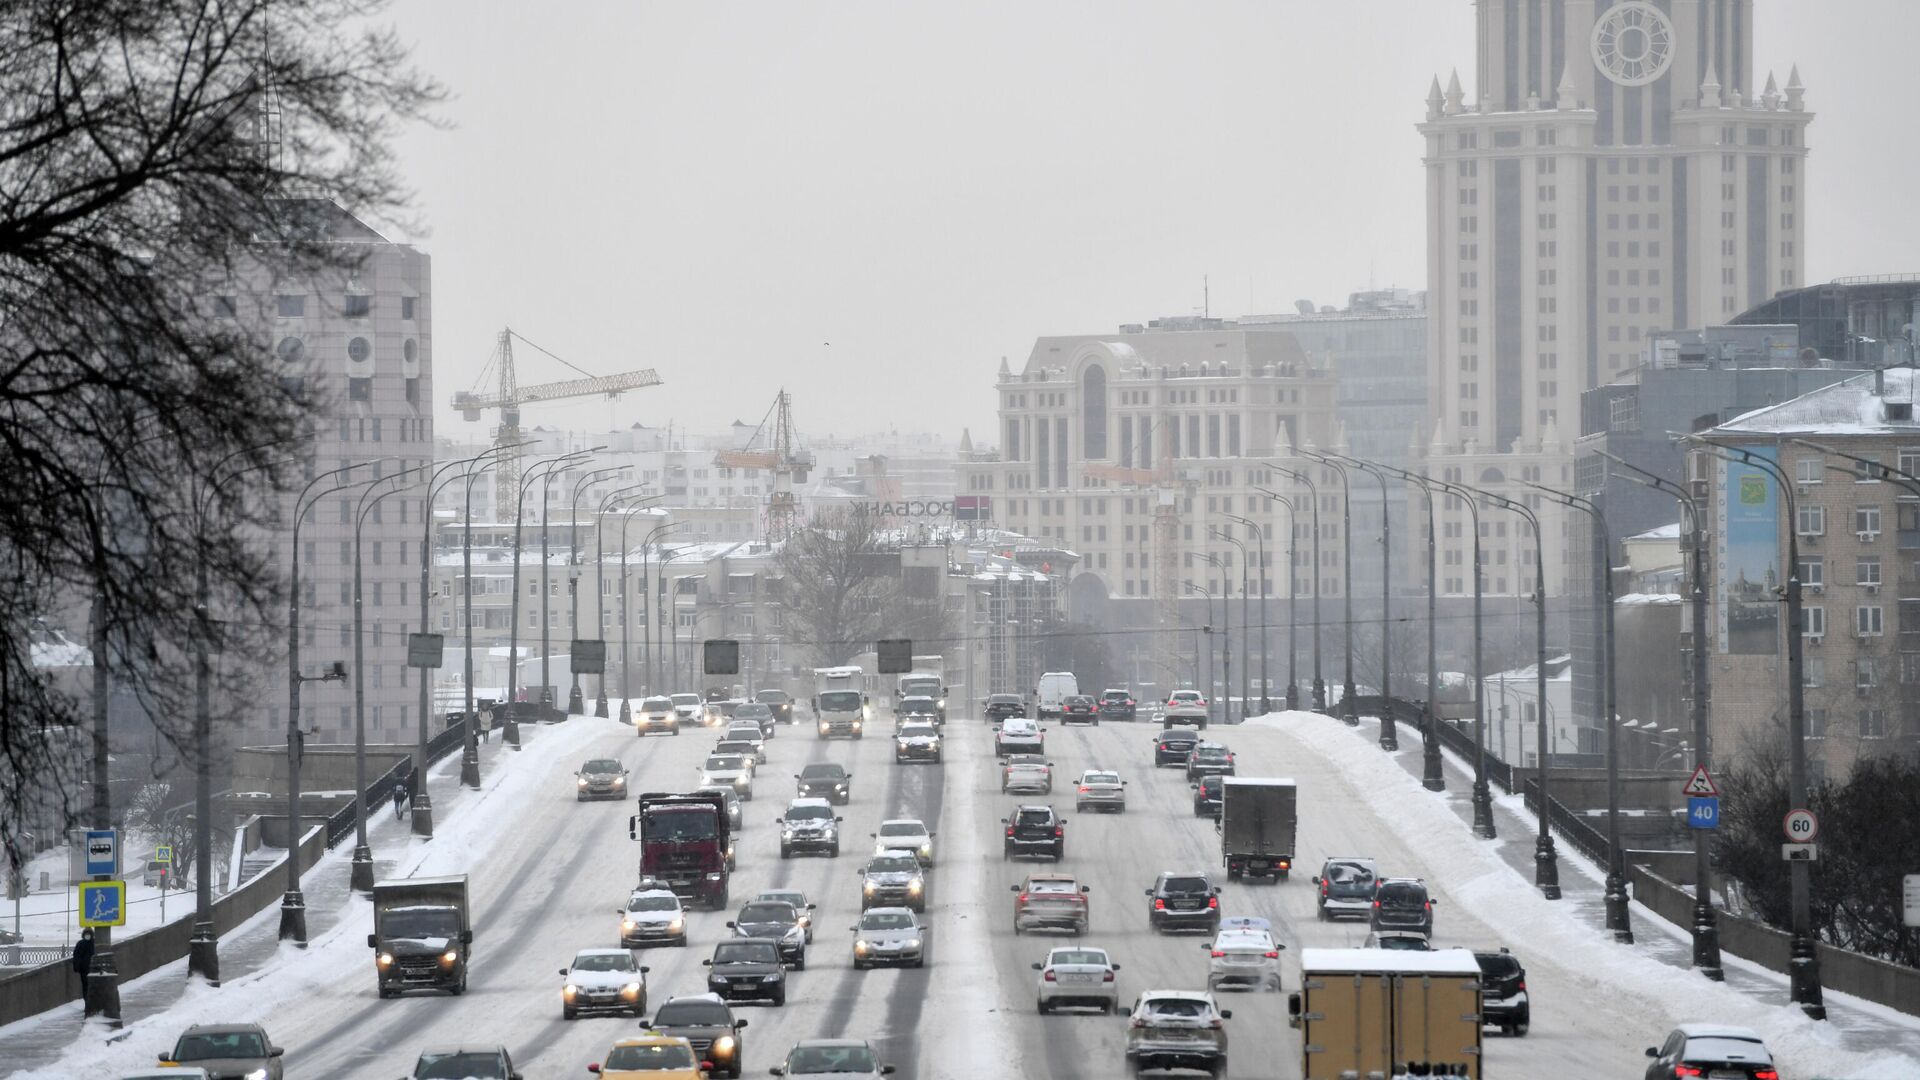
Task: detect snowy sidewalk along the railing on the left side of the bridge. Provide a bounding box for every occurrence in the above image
[0,724,526,1076]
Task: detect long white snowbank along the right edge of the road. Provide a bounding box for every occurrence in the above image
[1246,713,1920,1080]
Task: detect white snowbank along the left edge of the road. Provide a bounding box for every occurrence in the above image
[0,717,618,1080]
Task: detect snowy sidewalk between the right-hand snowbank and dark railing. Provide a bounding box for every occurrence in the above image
[1354,717,1920,1057]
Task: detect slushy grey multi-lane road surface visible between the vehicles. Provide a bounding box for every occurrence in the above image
[214,703,1667,1080]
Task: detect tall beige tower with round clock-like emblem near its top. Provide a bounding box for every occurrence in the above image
[1419,0,1812,594]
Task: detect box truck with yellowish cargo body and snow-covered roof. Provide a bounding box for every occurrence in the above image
[1286,949,1480,1080]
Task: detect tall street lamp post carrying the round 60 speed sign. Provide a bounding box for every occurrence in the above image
[1697,440,1820,1020]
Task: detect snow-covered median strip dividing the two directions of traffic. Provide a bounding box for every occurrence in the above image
[920,728,1021,1080]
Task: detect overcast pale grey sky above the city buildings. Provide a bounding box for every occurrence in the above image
[394,0,1920,440]
